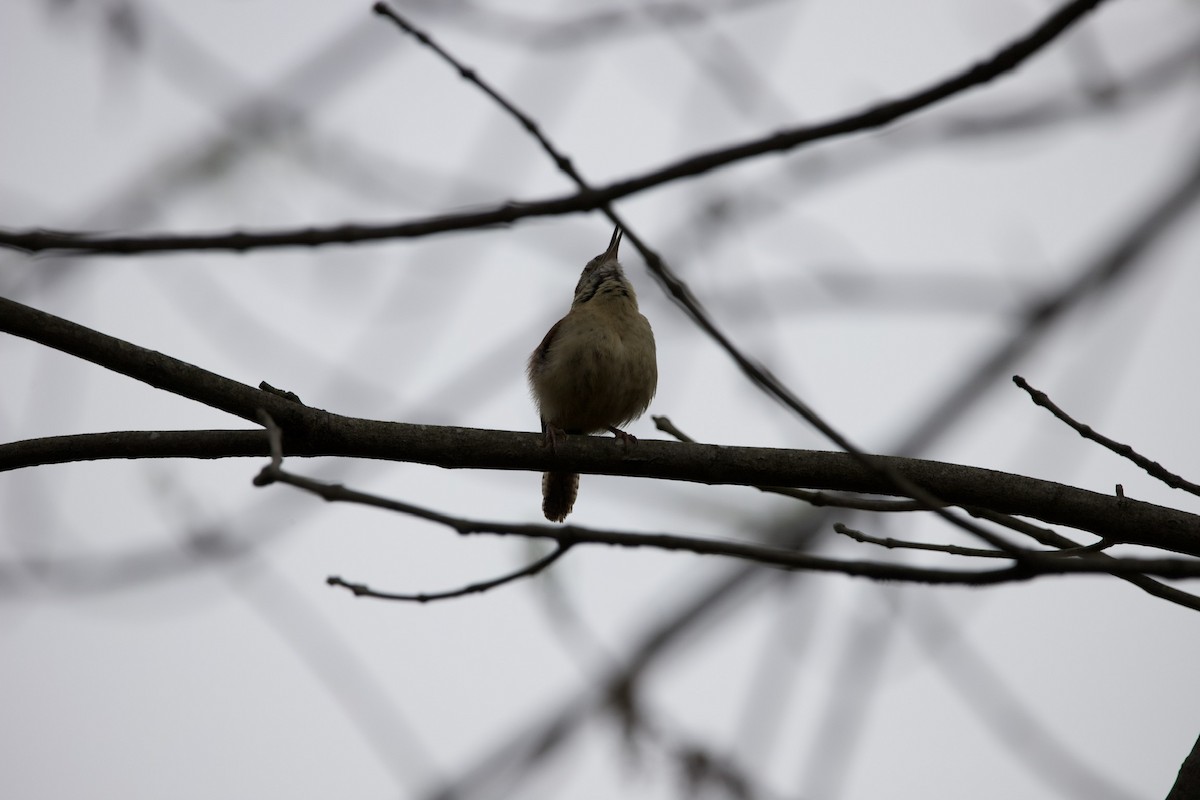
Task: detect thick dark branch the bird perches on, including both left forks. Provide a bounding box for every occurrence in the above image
[0,297,1200,555]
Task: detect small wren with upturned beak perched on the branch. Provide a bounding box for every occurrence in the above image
[527,228,659,522]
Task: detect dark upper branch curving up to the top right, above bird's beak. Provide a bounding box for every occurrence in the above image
[0,0,1104,253]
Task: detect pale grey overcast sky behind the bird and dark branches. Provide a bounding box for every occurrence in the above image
[0,0,1200,800]
